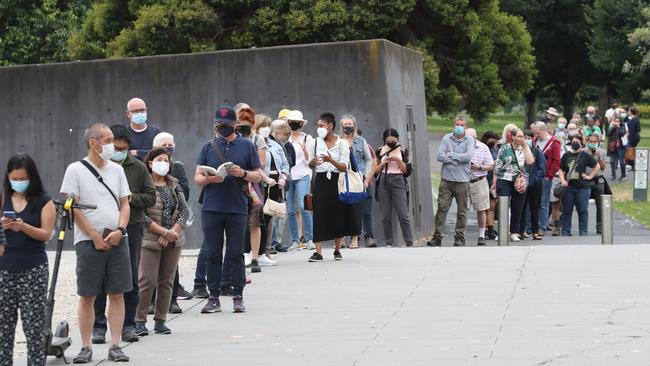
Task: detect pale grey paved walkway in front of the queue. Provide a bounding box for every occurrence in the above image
[38,245,650,366]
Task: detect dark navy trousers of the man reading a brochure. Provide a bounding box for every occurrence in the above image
[201,211,248,297]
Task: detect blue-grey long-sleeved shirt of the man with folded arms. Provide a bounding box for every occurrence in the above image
[438,133,474,182]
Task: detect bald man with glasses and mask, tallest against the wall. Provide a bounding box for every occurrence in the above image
[126,98,162,160]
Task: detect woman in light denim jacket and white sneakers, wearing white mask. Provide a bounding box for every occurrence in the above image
[255,114,290,266]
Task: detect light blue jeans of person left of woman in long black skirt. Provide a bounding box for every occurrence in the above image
[287,176,314,242]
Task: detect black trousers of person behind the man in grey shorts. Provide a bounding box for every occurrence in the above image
[93,224,144,332]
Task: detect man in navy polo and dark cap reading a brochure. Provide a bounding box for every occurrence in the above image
[194,104,262,313]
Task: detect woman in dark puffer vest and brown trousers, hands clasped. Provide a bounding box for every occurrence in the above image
[135,148,189,336]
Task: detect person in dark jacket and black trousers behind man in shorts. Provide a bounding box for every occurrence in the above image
[92,125,156,344]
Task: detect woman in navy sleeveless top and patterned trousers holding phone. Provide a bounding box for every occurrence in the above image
[0,154,56,365]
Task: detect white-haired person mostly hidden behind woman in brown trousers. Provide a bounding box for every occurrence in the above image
[149,132,191,314]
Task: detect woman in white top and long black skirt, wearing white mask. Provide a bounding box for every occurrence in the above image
[307,113,361,262]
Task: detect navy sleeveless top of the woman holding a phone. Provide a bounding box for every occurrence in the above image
[0,194,51,272]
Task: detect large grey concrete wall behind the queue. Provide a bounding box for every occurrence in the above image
[0,40,432,247]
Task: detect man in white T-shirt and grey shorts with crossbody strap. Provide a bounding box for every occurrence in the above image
[61,123,133,363]
